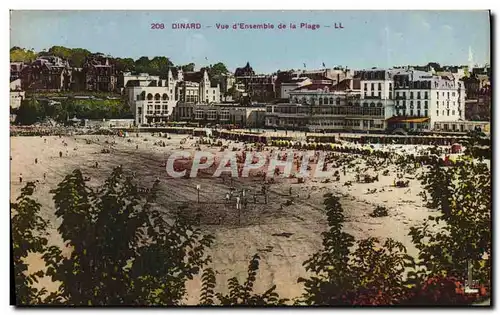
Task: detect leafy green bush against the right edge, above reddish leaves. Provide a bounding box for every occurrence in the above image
[410,158,492,285]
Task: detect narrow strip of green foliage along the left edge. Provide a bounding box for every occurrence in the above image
[10,182,47,305]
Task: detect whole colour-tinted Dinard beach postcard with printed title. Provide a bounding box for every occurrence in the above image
[10,10,493,307]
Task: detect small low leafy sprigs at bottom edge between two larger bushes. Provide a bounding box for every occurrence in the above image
[200,254,288,305]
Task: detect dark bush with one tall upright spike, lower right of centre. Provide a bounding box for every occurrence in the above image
[298,194,413,305]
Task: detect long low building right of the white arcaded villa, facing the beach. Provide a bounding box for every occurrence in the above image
[175,103,266,128]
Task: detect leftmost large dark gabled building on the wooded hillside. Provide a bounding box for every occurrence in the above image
[20,56,72,92]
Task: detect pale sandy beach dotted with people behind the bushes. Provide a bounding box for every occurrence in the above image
[10,134,431,304]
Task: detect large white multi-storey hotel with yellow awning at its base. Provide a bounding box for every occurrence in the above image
[389,70,465,130]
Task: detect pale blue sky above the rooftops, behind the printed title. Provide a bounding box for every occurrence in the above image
[10,11,490,73]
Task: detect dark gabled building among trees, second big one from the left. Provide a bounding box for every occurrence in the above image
[83,54,118,92]
